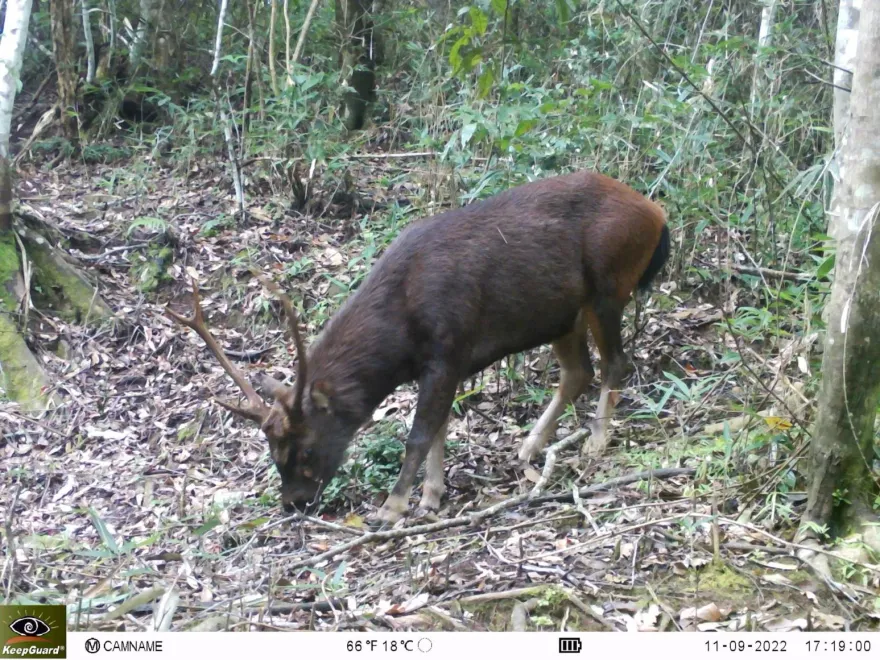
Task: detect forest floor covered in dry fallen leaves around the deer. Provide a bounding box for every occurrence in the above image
[0,152,878,631]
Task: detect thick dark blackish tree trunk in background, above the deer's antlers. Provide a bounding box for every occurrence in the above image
[336,0,378,131]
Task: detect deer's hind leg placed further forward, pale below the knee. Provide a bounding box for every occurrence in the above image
[519,312,593,462]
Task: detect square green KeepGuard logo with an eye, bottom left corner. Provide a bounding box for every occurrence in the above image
[0,605,67,660]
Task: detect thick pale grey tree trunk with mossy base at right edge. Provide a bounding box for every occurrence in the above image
[801,2,880,540]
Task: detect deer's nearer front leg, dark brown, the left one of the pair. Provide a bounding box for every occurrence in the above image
[373,366,458,523]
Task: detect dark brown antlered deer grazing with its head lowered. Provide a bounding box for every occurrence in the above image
[166,171,670,526]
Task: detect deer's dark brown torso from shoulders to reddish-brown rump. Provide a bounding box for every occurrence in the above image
[336,172,663,372]
